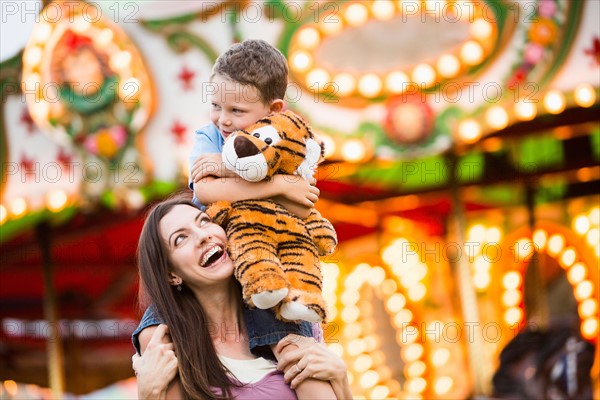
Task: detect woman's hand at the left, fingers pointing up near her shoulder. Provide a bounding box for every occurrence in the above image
[131,324,177,399]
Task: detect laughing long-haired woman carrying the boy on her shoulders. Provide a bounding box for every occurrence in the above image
[133,199,352,399]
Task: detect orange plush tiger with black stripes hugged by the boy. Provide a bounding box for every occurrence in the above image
[207,111,337,322]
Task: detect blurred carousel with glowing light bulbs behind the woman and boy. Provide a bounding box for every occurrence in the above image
[0,0,600,399]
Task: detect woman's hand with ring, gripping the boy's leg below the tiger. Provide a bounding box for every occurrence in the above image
[275,335,352,399]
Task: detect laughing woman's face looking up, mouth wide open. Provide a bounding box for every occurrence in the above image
[160,204,233,288]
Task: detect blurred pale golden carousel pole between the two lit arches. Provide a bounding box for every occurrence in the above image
[447,150,490,399]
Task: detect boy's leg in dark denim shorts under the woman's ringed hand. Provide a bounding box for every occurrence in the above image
[244,308,336,400]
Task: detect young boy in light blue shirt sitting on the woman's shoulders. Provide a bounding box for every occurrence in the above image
[133,40,335,399]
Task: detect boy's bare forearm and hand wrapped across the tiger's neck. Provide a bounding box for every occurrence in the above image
[194,175,319,212]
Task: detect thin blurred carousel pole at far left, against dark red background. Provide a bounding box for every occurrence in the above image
[36,222,65,399]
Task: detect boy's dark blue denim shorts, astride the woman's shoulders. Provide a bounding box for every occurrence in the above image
[131,305,313,360]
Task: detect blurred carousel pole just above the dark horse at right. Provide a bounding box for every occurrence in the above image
[523,182,549,331]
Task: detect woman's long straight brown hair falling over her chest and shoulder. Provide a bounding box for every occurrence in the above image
[137,197,239,399]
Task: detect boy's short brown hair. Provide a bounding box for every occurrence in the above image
[211,40,288,104]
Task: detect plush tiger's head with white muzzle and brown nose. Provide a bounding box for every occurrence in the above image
[222,110,323,182]
